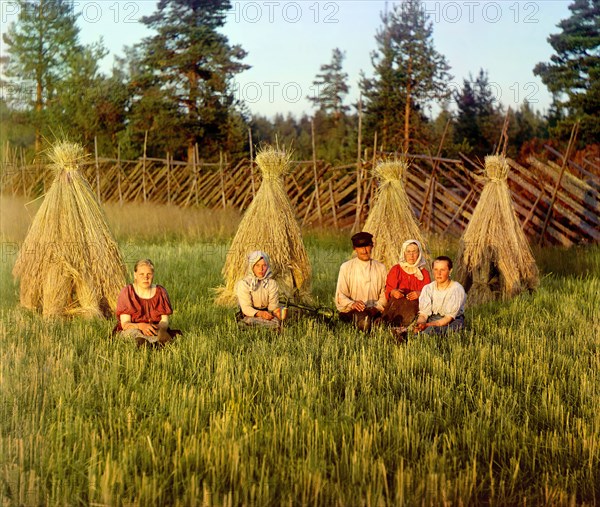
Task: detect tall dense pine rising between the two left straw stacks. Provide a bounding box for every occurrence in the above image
[138,0,248,160]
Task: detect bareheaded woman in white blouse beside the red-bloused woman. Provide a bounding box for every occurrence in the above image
[415,255,467,334]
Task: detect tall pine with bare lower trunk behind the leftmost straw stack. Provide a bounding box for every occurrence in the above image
[2,0,81,152]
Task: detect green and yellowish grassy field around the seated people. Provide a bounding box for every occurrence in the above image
[0,198,600,506]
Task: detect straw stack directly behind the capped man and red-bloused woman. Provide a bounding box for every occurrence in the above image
[363,159,428,270]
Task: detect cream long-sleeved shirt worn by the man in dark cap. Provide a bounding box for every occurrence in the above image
[335,257,387,313]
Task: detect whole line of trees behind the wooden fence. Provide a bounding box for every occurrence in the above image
[0,0,600,162]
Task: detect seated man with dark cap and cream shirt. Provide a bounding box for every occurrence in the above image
[335,232,387,331]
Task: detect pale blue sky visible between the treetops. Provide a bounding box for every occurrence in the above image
[0,0,571,116]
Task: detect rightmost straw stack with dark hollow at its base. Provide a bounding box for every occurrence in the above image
[456,155,539,304]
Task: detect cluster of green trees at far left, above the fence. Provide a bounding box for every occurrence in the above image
[4,0,126,152]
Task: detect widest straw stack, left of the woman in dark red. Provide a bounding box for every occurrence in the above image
[13,141,125,317]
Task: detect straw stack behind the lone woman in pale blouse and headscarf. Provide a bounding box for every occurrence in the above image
[216,146,311,306]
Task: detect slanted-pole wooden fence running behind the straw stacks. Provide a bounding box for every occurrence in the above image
[0,147,600,246]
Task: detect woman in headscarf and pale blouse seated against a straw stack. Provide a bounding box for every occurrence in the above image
[235,250,281,327]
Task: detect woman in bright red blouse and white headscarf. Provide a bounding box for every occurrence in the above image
[383,239,431,334]
